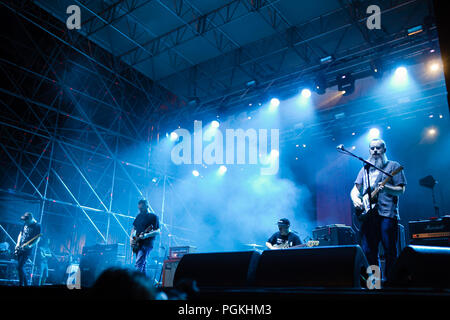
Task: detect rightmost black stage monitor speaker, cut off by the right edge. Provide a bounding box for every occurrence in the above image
[389,246,450,288]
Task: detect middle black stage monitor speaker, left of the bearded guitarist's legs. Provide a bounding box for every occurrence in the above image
[255,245,368,288]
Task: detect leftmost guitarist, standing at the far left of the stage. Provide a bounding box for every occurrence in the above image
[16,212,41,286]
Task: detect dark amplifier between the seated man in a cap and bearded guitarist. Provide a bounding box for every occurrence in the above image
[312,224,356,247]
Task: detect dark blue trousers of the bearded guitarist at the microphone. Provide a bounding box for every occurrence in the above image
[361,214,398,279]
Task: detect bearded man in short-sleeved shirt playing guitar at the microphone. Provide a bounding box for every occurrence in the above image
[350,139,406,278]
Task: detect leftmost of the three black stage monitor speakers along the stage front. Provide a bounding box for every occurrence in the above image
[174,251,260,288]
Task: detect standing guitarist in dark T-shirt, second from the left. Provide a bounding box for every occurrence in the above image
[130,200,160,274]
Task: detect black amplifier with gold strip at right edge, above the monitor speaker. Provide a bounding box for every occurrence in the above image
[409,215,450,247]
